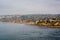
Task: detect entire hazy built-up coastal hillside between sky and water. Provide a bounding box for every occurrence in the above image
[0,14,60,27]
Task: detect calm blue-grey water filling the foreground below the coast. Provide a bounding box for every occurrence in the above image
[0,23,60,40]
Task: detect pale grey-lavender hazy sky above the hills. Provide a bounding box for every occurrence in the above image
[0,0,60,15]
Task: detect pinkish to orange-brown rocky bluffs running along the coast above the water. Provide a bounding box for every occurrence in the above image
[0,20,60,28]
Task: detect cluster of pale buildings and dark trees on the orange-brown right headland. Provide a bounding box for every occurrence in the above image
[36,18,60,26]
